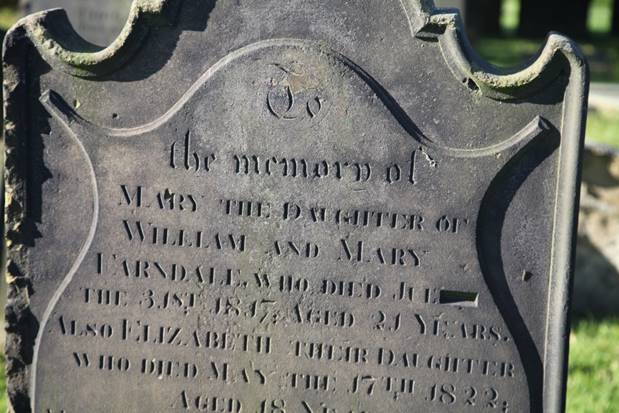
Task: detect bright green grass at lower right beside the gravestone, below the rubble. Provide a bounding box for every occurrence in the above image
[567,320,619,413]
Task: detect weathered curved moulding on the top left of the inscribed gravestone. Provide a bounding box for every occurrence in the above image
[17,0,181,78]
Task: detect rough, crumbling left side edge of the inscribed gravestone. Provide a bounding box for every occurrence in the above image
[3,20,37,413]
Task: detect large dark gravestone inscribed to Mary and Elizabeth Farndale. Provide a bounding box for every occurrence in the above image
[4,0,587,413]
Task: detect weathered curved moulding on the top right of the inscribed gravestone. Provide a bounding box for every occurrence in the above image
[410,0,588,100]
